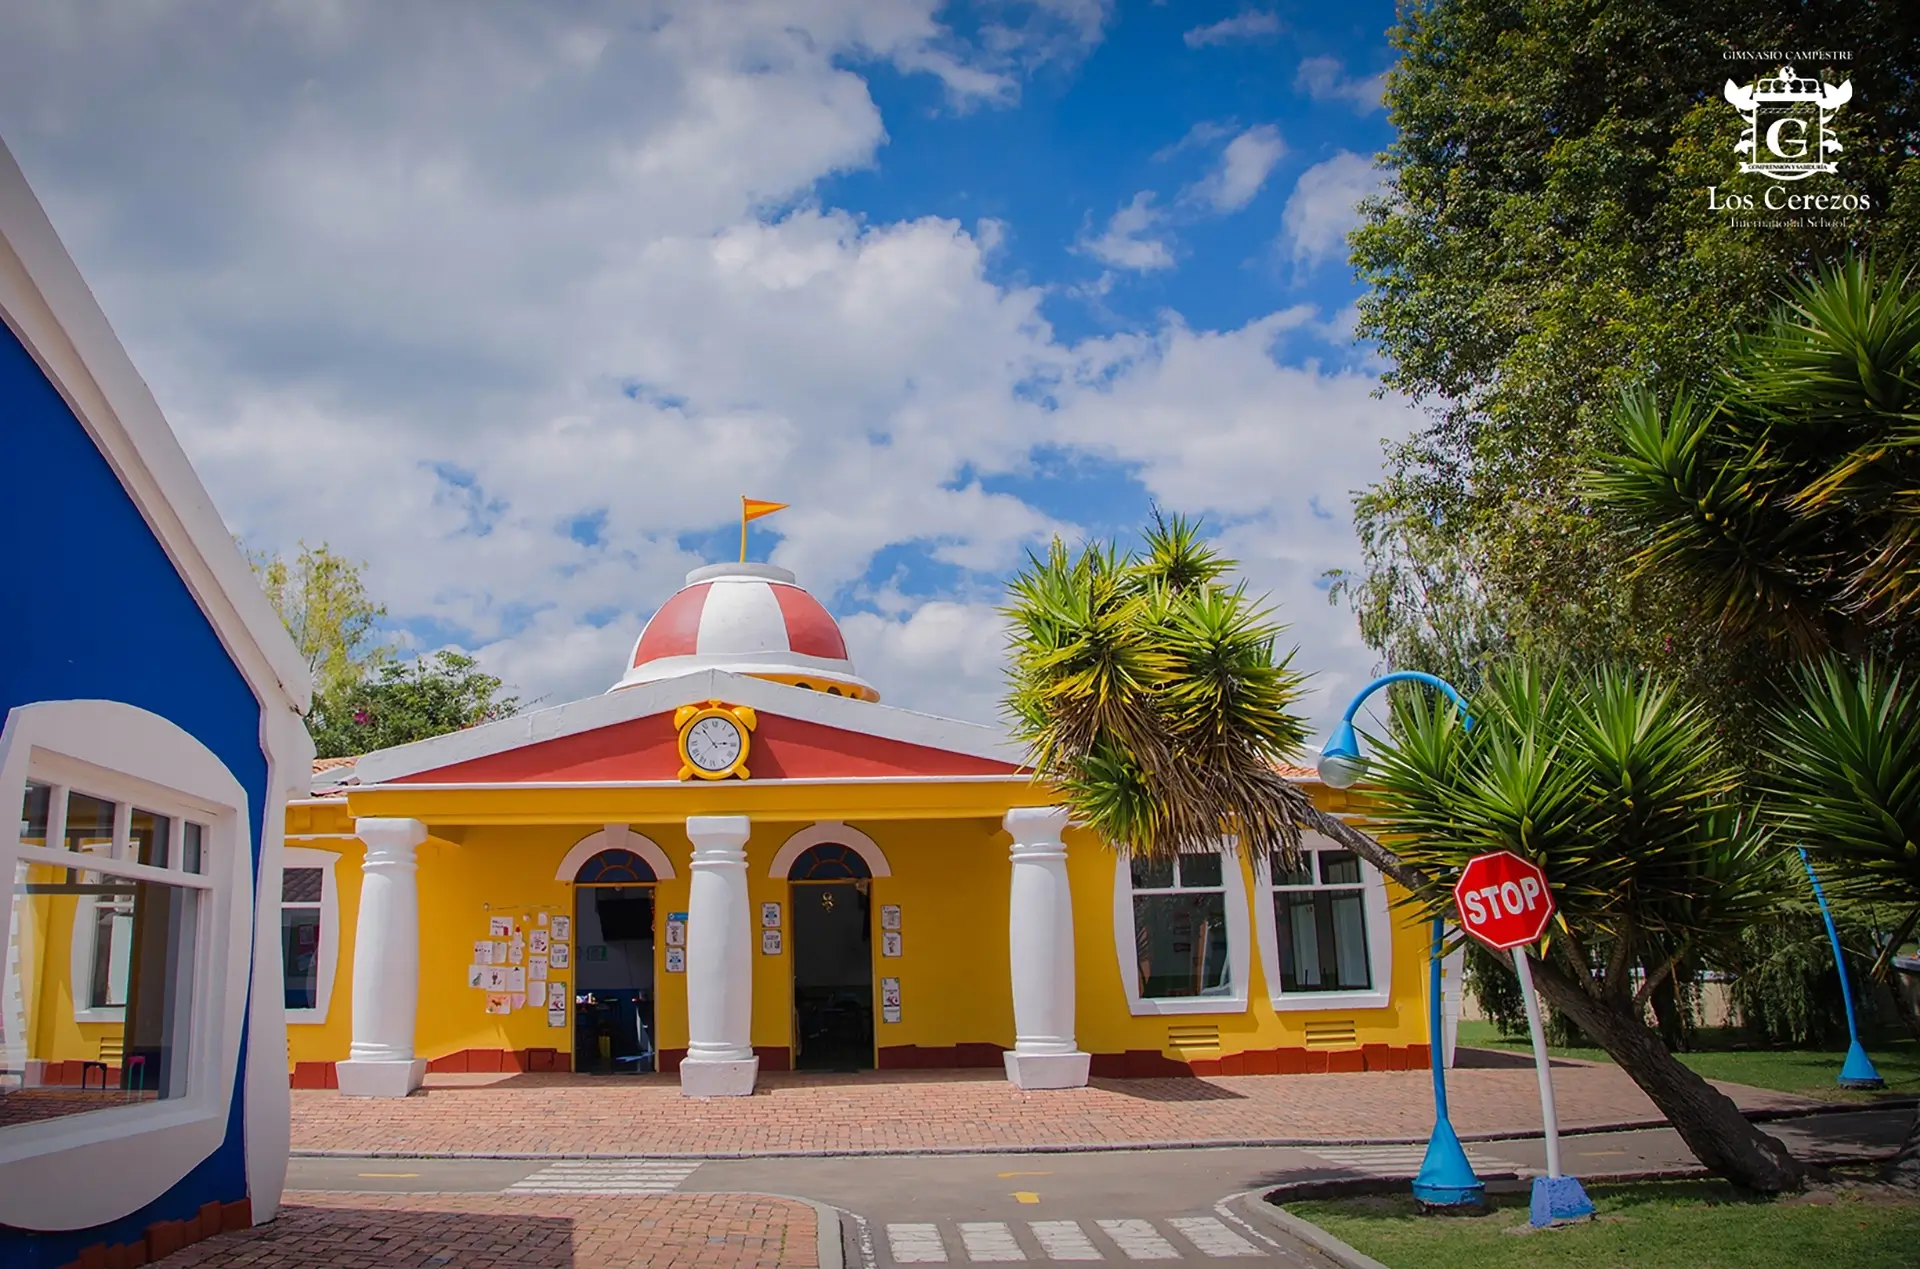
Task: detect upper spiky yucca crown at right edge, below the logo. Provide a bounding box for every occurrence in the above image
[1590,257,1920,658]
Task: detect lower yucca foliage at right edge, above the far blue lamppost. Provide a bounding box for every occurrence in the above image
[1766,658,1920,1185]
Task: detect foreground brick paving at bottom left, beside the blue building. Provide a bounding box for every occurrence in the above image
[152,1192,820,1269]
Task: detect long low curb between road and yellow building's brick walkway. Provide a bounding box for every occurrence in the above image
[290,1098,1920,1161]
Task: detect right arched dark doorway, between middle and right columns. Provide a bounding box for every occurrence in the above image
[787,847,874,1071]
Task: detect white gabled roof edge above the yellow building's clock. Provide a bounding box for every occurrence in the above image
[353,670,1027,787]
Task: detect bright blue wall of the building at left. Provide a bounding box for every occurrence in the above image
[0,314,267,1269]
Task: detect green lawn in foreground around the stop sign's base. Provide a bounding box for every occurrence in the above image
[1286,1181,1920,1269]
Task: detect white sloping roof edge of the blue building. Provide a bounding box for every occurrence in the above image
[0,140,313,714]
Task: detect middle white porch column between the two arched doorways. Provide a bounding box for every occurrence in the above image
[680,816,760,1096]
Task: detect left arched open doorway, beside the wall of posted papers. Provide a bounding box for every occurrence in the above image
[572,850,657,1075]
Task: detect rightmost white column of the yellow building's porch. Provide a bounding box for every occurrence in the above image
[1004,806,1092,1089]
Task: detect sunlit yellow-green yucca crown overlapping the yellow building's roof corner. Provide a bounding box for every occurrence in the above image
[1004,513,1317,856]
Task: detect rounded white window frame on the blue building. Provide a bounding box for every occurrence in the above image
[0,701,253,1229]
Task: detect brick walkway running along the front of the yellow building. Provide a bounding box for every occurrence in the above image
[294,1062,1812,1156]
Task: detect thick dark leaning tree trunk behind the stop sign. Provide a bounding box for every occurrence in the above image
[1534,960,1807,1194]
